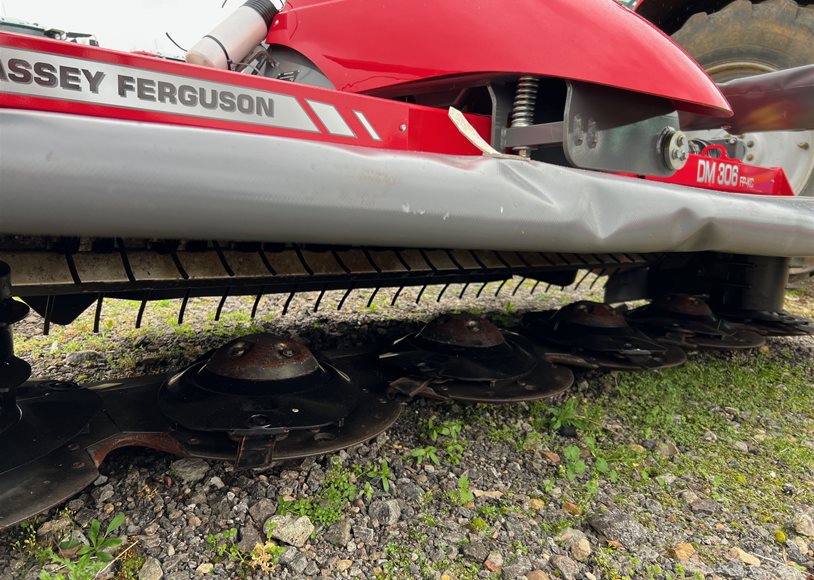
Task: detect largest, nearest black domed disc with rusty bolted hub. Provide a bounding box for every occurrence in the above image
[159,334,359,436]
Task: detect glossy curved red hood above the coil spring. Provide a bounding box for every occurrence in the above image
[268,0,730,116]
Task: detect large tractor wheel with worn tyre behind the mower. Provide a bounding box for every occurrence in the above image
[673,0,814,196]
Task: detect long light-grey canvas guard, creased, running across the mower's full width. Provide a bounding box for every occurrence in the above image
[0,110,814,256]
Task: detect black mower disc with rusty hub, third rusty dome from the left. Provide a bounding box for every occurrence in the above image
[523,301,687,370]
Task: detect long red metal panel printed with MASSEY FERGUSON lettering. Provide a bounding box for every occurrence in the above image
[0,32,491,155]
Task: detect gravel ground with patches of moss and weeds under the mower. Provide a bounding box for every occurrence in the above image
[0,283,814,580]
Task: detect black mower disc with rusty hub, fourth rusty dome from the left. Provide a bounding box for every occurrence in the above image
[625,294,766,350]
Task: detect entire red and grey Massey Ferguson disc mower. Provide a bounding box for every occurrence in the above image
[0,0,814,527]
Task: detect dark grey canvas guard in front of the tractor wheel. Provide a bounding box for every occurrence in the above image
[681,65,814,134]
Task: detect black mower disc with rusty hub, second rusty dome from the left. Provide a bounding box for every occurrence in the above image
[379,314,574,403]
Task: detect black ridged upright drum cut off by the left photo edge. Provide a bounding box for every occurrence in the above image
[0,262,31,433]
